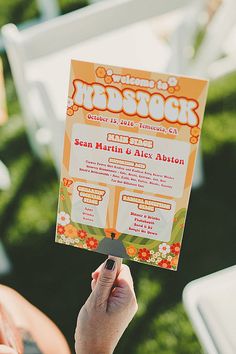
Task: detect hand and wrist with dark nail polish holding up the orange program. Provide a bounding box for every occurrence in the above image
[75,257,138,354]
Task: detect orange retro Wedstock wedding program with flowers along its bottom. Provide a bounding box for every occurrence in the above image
[56,60,208,270]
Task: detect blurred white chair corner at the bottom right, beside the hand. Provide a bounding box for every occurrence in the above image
[183,266,236,354]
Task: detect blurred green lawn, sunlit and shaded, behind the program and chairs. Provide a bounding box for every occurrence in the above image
[0,0,236,354]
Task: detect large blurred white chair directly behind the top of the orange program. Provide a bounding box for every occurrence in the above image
[2,0,205,187]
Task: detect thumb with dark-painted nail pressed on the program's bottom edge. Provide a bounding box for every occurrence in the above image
[93,256,122,305]
